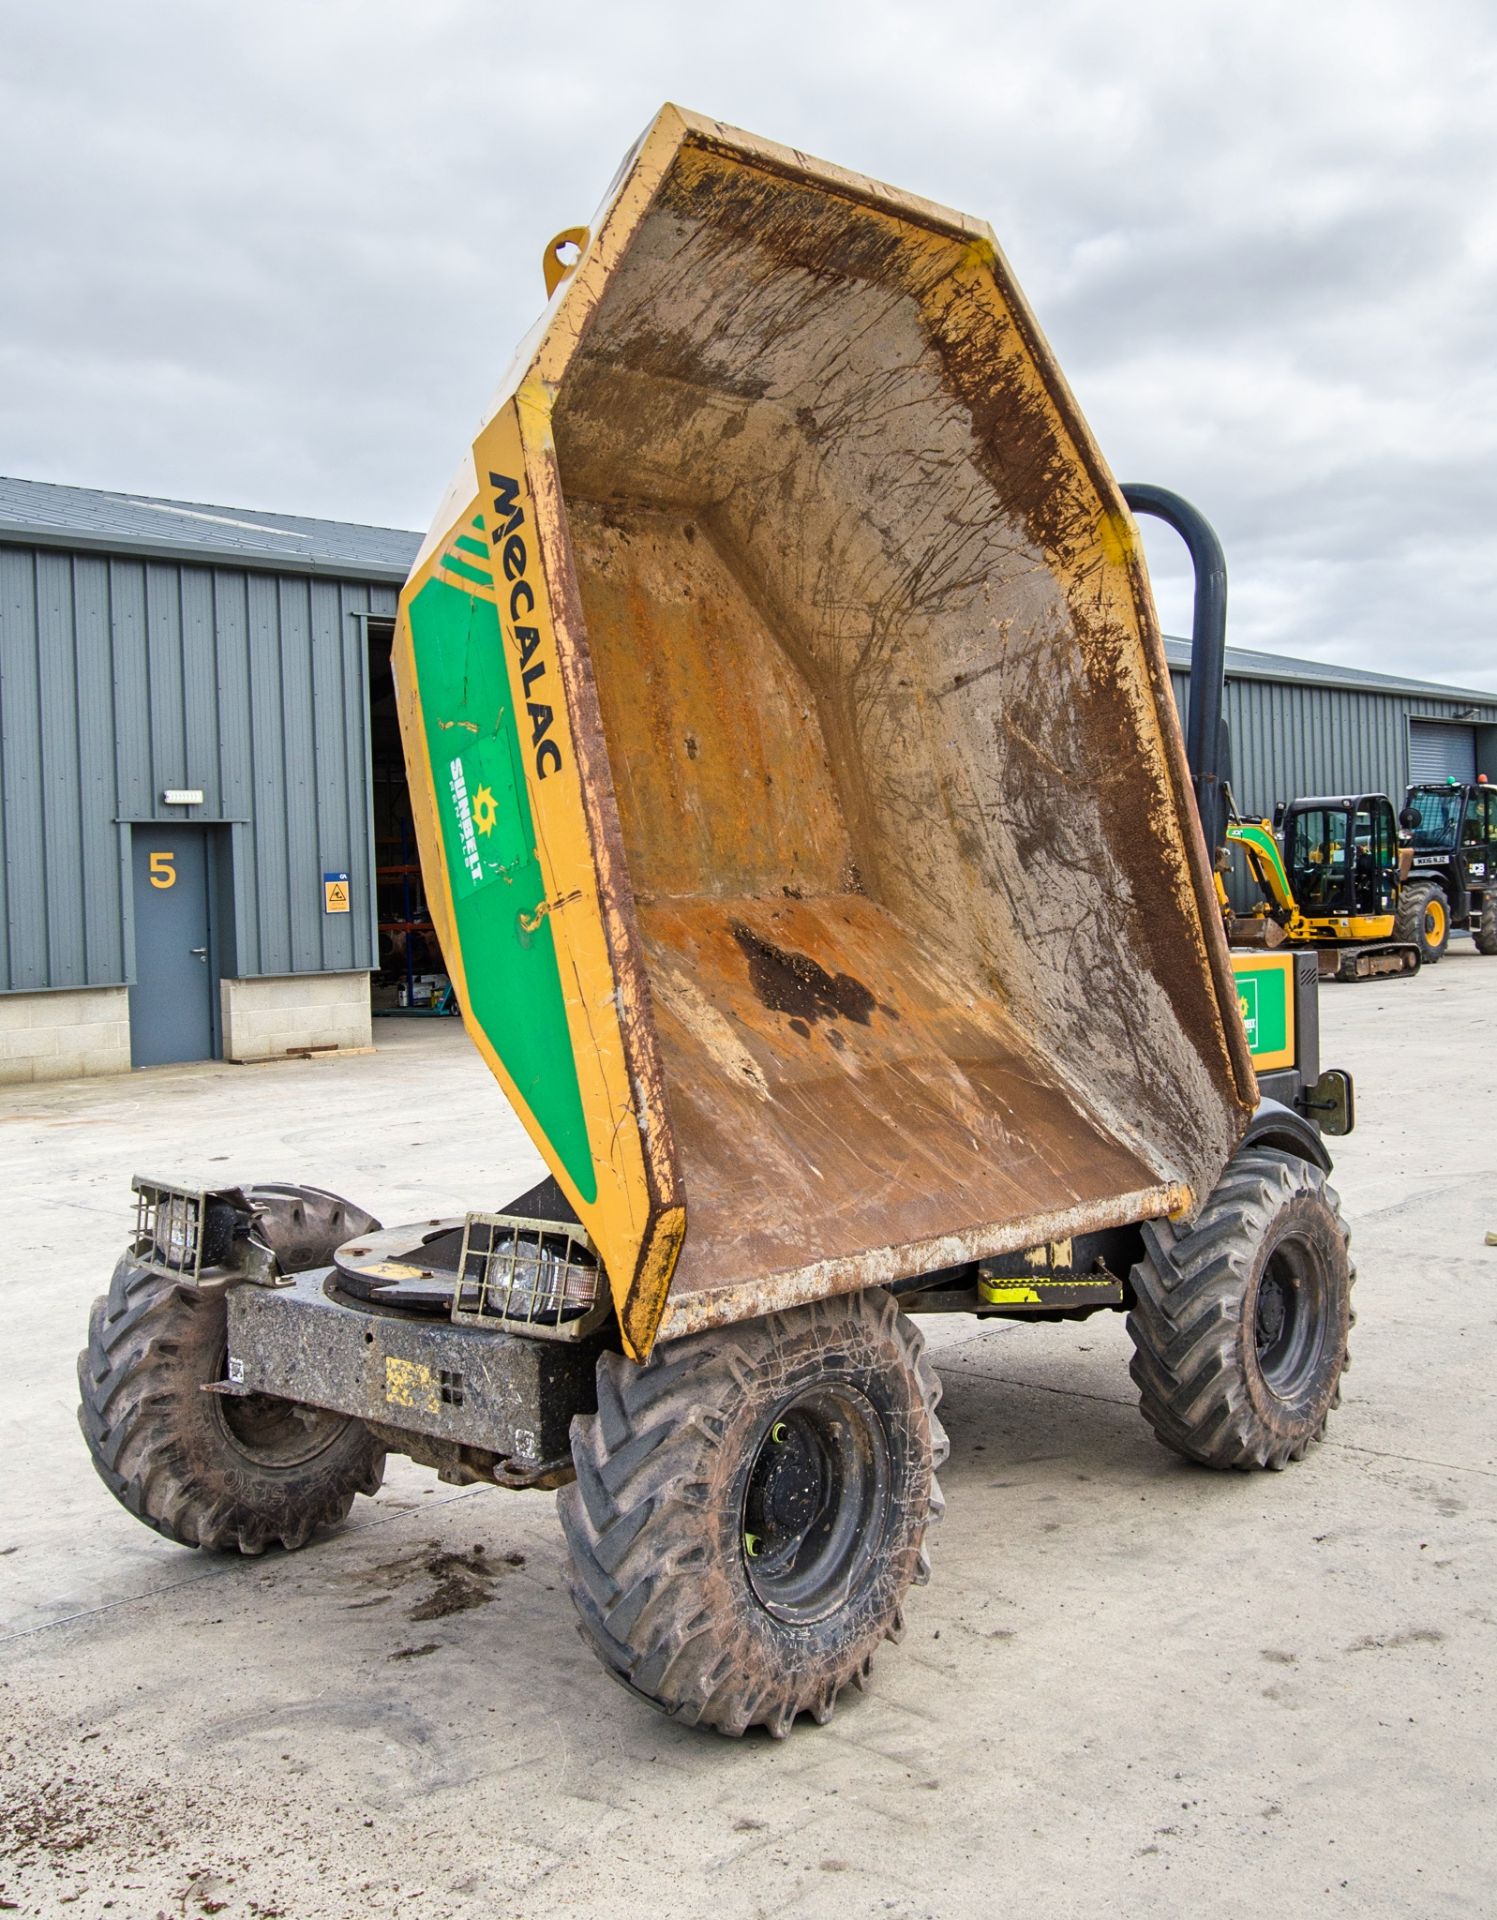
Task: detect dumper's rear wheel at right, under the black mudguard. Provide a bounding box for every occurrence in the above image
[1129,1148,1355,1469]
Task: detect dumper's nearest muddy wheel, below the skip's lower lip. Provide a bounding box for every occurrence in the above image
[558,1290,946,1738]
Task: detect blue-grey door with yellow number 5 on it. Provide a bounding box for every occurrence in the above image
[131,826,219,1068]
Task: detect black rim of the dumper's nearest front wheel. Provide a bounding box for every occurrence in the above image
[743,1382,891,1624]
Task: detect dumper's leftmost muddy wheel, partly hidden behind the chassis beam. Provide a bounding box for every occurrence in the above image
[79,1256,384,1553]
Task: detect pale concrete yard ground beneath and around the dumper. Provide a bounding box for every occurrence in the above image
[0,943,1497,1920]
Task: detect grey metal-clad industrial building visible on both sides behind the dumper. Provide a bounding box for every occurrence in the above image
[0,480,1497,1081]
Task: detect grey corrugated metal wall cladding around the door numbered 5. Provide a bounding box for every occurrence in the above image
[0,537,395,991]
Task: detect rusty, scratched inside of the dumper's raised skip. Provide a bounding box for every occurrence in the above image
[555,131,1242,1323]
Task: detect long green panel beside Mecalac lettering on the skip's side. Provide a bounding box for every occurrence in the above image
[411,580,597,1202]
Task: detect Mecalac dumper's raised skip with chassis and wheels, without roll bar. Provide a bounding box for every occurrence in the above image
[81,108,1351,1736]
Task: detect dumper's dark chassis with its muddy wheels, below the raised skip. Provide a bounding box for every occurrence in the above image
[79,1102,1355,1738]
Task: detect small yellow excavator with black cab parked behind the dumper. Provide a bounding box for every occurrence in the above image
[1217,793,1422,979]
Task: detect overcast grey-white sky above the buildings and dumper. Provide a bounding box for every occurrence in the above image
[0,0,1497,687]
